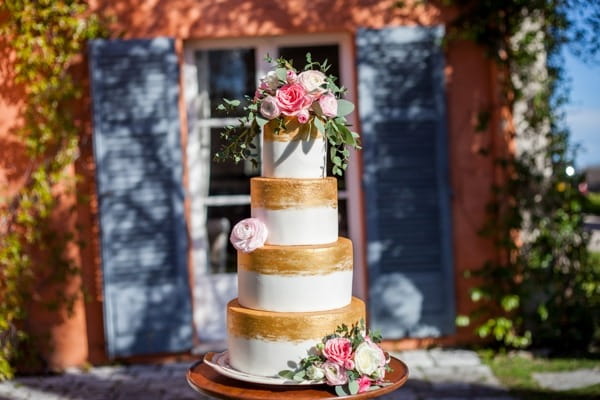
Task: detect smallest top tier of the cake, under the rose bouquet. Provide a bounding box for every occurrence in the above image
[261,118,327,179]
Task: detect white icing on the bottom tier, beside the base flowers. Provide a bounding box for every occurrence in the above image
[227,335,321,376]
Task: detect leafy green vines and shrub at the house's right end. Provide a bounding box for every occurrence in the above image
[450,0,600,351]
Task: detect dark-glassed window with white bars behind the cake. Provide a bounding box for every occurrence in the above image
[195,44,348,273]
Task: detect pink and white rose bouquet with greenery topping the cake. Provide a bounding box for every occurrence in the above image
[215,53,360,175]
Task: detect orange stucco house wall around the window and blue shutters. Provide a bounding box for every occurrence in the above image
[0,0,503,366]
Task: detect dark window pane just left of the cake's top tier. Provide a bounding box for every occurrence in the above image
[208,128,260,196]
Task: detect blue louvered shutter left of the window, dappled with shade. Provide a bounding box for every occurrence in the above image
[90,38,192,357]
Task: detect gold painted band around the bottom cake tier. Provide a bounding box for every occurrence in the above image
[227,293,366,342]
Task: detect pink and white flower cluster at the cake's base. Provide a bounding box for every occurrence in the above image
[279,320,392,396]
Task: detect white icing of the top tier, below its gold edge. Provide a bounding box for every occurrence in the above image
[261,138,327,178]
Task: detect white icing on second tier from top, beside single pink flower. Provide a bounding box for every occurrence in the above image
[252,207,338,246]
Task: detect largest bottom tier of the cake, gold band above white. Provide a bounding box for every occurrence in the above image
[227,297,366,376]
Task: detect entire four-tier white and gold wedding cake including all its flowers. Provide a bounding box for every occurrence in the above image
[217,54,389,390]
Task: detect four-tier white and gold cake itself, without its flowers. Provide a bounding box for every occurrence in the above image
[227,119,365,376]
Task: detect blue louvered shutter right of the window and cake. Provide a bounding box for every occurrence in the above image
[356,27,455,338]
